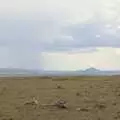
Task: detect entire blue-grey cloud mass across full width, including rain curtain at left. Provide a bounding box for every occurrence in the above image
[0,19,120,69]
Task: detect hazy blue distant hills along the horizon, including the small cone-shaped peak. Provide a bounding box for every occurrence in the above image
[0,67,120,76]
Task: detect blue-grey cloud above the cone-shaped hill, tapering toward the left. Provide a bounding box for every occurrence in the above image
[43,22,120,51]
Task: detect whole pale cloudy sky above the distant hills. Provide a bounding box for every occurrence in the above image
[0,0,120,71]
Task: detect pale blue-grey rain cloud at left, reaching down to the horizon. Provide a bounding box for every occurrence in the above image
[0,19,63,69]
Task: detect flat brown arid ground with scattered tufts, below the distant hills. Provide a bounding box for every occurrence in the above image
[0,76,120,120]
